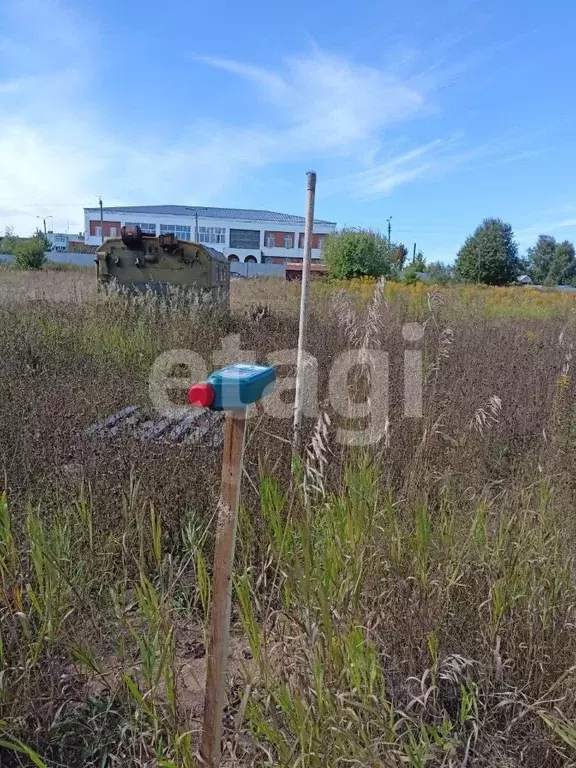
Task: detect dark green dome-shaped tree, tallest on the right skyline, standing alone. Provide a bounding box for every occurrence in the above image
[456,219,522,285]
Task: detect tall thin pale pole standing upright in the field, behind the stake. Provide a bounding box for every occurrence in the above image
[292,171,316,451]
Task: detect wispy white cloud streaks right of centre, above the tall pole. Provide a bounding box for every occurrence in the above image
[200,50,547,199]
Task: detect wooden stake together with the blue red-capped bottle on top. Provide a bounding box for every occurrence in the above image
[188,363,276,768]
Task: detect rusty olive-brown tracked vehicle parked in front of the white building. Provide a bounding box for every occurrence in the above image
[96,226,230,307]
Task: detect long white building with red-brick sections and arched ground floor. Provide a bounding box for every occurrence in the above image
[84,205,336,264]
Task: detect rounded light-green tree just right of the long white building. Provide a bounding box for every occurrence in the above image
[324,229,398,279]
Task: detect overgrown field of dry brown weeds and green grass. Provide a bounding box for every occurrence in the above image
[0,267,576,768]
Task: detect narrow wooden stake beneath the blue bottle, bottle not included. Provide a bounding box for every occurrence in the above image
[200,411,246,768]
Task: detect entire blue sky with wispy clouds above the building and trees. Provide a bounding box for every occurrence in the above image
[0,0,576,262]
